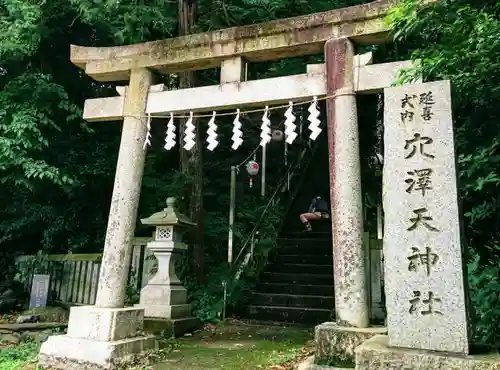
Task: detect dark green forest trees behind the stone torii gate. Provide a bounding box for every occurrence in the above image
[0,0,500,344]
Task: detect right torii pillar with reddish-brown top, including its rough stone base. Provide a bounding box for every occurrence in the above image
[315,38,387,362]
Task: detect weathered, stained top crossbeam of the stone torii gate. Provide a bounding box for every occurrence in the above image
[71,0,395,81]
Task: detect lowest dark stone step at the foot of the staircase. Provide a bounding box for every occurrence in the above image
[247,305,333,325]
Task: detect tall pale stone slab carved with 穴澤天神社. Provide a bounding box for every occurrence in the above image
[383,81,469,354]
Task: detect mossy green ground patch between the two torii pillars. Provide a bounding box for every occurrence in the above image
[149,324,313,370]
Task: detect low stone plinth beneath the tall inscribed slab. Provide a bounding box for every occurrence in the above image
[356,335,500,370]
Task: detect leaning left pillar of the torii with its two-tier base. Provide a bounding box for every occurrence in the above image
[39,68,156,369]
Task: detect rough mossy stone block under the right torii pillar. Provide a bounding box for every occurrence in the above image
[314,322,387,366]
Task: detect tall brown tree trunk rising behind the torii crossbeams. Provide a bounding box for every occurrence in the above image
[179,0,205,282]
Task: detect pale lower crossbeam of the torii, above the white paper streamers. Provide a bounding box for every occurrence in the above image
[83,58,413,122]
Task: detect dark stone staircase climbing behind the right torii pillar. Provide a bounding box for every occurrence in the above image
[247,230,334,325]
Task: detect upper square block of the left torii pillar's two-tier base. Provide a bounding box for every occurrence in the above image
[64,306,144,342]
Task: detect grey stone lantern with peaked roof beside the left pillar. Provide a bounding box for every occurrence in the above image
[136,198,197,334]
